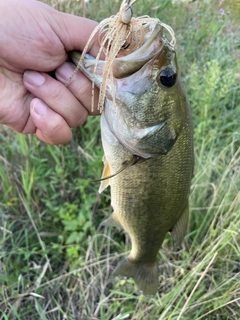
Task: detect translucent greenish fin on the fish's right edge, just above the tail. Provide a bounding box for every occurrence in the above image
[171,204,189,249]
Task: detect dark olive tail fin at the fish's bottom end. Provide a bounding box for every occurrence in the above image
[113,258,158,296]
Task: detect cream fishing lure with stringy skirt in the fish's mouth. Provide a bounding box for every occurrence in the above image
[66,0,176,113]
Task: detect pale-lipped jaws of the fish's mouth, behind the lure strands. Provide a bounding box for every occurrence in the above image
[70,23,164,82]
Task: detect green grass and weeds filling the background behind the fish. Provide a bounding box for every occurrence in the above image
[0,0,240,320]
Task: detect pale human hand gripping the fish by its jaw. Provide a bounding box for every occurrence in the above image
[0,0,98,144]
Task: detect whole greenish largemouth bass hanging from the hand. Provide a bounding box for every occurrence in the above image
[72,24,193,295]
